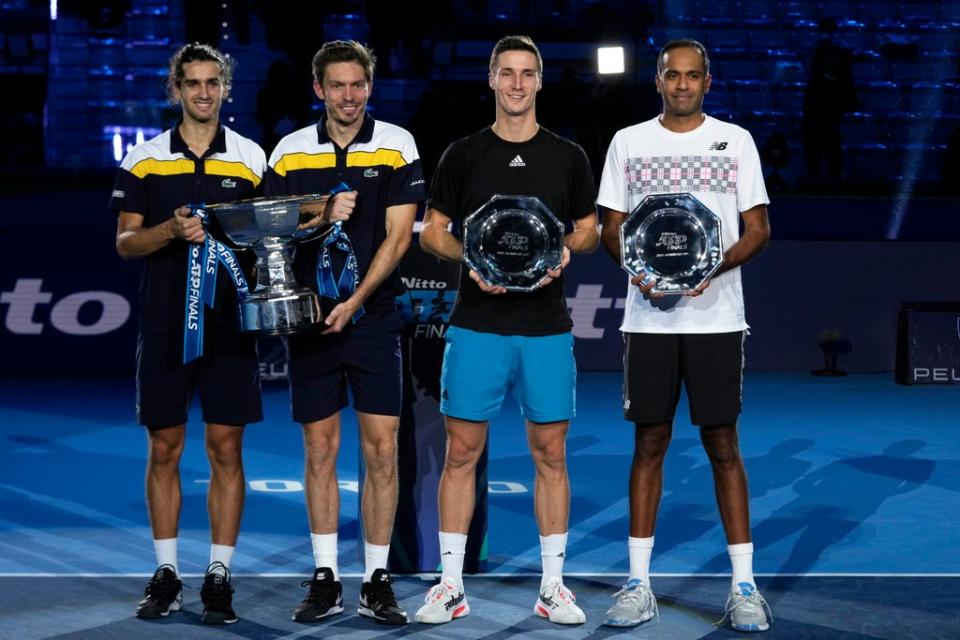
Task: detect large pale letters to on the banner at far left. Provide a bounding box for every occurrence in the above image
[0,278,130,336]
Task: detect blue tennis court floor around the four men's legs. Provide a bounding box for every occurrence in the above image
[0,373,960,638]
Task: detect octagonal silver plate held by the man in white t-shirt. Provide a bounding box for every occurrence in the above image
[620,193,723,293]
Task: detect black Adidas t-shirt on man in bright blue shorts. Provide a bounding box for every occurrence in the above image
[427,127,596,336]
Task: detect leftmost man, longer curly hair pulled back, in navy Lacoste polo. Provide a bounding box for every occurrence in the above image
[110,43,266,624]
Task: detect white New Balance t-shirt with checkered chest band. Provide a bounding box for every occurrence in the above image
[597,116,770,333]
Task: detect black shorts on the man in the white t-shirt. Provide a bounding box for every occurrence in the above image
[623,331,745,426]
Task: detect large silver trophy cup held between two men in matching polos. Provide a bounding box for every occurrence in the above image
[206,195,323,335]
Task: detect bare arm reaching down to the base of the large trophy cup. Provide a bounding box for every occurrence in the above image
[324,203,417,333]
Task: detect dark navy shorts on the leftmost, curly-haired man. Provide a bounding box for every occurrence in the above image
[137,326,263,429]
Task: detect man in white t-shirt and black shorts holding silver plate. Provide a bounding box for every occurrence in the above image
[597,40,770,631]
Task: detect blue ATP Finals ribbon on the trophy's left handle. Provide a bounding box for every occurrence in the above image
[183,204,250,364]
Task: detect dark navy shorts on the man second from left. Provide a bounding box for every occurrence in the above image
[287,309,403,423]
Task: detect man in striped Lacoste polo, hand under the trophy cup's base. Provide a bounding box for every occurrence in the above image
[265,40,424,624]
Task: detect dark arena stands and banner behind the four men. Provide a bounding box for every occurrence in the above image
[0,0,960,375]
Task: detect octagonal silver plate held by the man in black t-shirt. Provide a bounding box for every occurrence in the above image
[463,195,563,291]
